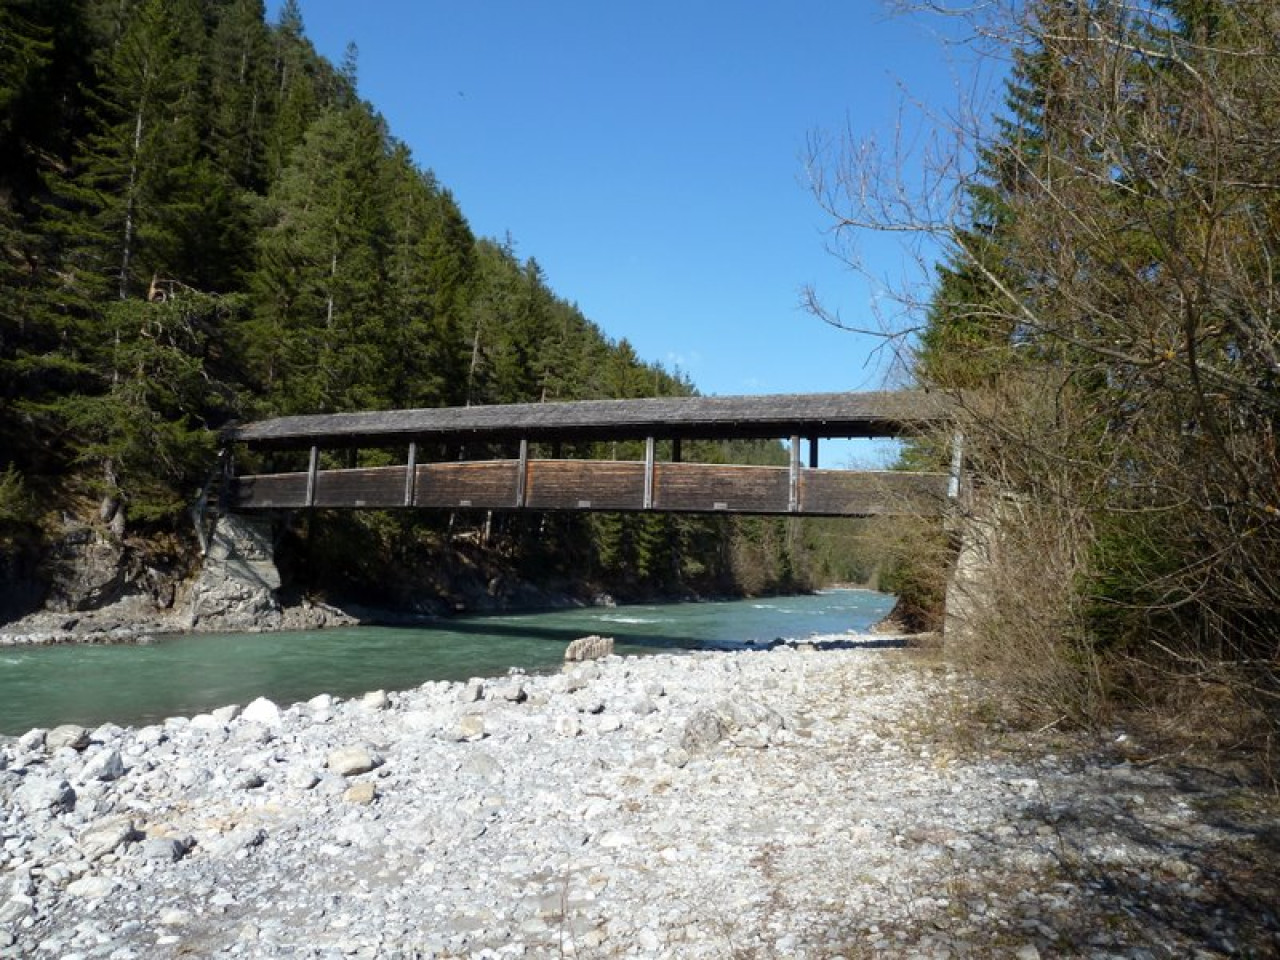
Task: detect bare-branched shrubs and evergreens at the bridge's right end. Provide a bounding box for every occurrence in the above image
[823,0,1280,762]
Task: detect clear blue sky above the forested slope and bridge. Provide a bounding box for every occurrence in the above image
[269,0,955,463]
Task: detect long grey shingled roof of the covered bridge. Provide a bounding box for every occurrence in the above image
[228,390,952,448]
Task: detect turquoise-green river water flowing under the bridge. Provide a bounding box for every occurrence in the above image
[0,590,893,735]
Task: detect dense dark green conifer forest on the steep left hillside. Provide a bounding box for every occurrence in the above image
[0,0,870,616]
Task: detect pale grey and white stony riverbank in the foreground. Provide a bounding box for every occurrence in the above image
[0,637,1280,960]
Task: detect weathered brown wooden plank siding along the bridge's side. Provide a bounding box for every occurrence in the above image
[229,460,948,517]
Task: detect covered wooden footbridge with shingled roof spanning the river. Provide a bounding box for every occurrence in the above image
[225,390,959,516]
